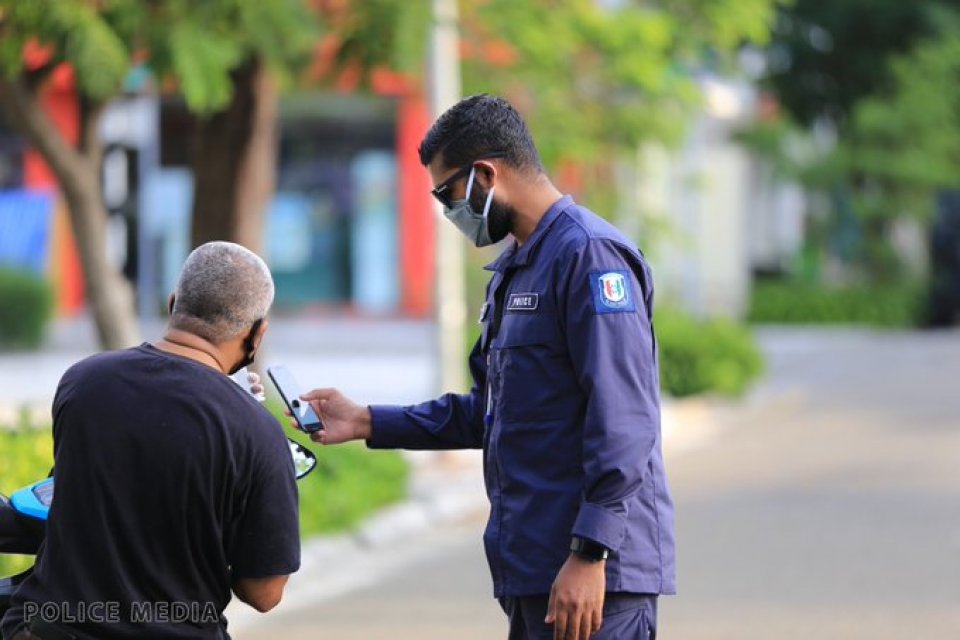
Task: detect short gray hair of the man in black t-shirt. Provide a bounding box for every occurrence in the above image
[170,241,273,344]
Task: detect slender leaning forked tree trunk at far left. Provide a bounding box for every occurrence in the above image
[0,77,139,356]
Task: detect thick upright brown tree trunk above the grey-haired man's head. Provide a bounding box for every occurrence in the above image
[191,58,278,253]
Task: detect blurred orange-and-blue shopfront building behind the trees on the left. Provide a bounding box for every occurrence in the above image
[0,76,434,317]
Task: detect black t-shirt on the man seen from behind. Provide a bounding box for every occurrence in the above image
[3,344,300,639]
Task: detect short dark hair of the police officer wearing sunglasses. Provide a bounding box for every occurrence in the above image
[419,94,543,172]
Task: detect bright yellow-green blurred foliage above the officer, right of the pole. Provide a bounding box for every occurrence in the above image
[461,0,775,172]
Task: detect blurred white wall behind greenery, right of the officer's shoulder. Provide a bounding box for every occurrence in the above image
[618,77,804,318]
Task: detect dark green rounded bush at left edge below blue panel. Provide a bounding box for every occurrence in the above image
[0,268,53,349]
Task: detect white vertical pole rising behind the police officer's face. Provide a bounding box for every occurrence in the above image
[427,0,467,393]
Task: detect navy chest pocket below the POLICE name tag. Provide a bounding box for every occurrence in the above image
[495,309,579,428]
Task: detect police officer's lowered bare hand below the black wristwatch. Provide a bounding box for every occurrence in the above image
[545,553,607,640]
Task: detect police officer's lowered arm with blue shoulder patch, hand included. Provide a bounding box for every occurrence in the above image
[546,240,660,638]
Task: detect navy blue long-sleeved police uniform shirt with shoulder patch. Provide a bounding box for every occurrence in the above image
[368,197,675,597]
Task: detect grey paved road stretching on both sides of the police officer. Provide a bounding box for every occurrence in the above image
[235,330,960,640]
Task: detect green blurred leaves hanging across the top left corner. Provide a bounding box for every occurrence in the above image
[0,0,320,113]
